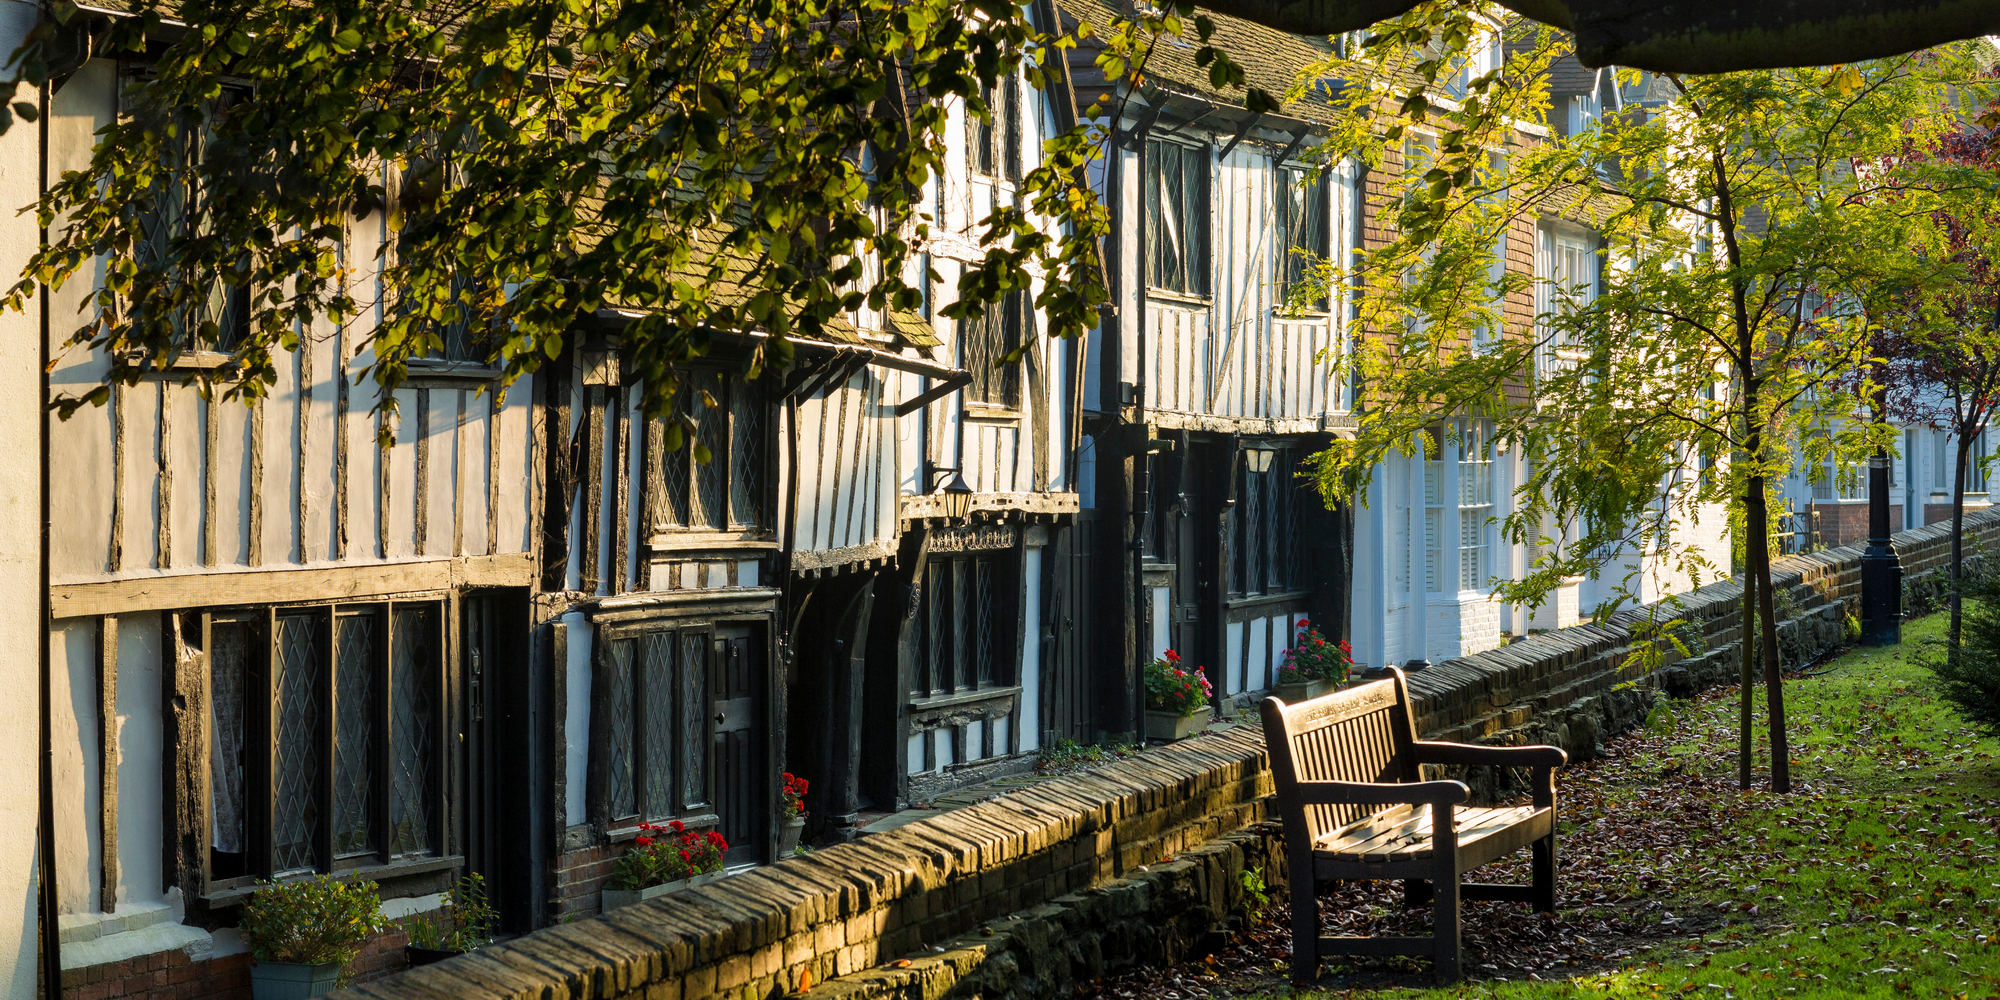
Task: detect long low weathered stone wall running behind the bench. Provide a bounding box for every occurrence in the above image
[338,512,2000,1000]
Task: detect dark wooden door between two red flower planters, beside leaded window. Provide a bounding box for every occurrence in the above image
[708,624,772,864]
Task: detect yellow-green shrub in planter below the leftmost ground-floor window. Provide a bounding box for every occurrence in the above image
[242,874,388,966]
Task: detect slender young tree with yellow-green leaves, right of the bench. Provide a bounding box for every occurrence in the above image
[1318,19,1978,790]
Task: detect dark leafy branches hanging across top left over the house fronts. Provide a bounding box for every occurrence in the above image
[6,0,1260,438]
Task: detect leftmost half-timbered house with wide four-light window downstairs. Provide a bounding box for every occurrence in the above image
[42,58,542,974]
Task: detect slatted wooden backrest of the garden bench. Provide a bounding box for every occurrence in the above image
[1262,668,1418,844]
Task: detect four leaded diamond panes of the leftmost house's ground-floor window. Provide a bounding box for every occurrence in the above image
[194,600,448,890]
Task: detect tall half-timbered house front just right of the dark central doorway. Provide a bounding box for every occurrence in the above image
[854,15,1098,810]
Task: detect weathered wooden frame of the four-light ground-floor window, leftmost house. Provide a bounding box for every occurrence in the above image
[185,592,464,908]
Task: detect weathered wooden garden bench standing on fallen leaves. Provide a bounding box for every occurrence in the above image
[1262,670,1568,984]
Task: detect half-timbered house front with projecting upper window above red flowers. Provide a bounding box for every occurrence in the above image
[536,310,956,916]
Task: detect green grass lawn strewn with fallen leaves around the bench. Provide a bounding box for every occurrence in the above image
[1106,614,2000,1000]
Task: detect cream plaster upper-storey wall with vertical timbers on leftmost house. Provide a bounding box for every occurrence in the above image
[41,58,534,586]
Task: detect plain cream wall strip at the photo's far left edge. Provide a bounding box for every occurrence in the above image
[0,0,45,996]
